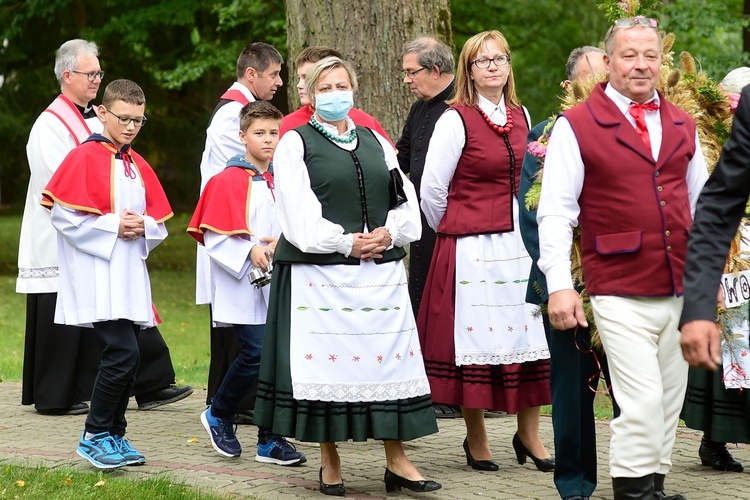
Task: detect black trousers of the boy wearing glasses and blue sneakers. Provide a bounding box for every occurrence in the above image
[86,319,140,436]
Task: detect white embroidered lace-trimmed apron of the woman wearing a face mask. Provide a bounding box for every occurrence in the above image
[290,262,430,402]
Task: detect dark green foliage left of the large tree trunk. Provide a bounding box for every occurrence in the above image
[0,0,286,210]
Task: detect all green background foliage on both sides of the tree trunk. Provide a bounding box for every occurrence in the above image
[0,0,748,211]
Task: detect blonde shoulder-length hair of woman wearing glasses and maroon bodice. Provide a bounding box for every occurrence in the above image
[448,30,521,108]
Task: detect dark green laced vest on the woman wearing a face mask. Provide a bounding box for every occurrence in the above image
[274,124,406,265]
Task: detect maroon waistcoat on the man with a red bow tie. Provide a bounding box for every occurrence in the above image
[564,84,696,296]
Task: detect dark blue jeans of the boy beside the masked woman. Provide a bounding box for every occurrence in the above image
[211,325,265,418]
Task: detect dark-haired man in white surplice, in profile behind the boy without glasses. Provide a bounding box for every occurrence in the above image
[195,42,284,424]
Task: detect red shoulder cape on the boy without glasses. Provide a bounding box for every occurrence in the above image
[187,155,273,245]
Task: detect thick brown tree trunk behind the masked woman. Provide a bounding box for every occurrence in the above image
[286,0,452,142]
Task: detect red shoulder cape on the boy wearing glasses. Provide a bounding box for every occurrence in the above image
[41,134,174,222]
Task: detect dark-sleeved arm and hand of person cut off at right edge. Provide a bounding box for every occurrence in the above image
[680,86,750,370]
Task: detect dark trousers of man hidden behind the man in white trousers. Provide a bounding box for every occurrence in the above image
[542,314,620,498]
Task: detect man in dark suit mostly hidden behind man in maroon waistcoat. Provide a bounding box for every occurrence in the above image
[518,47,619,500]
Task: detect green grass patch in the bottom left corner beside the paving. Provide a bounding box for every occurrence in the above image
[0,462,238,500]
